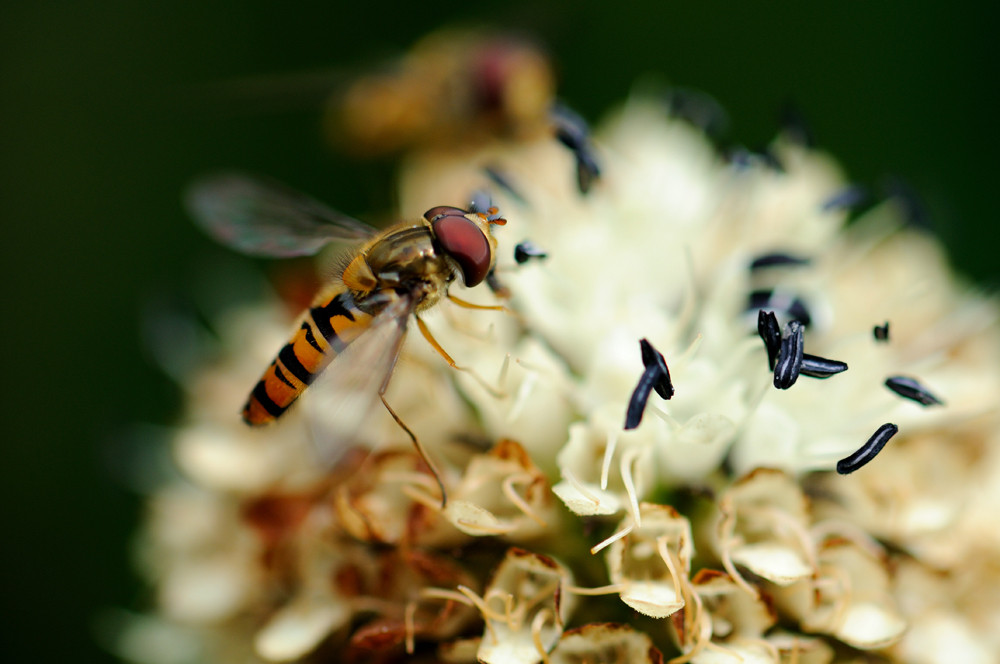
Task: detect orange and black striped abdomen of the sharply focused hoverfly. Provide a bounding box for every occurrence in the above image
[243,291,372,426]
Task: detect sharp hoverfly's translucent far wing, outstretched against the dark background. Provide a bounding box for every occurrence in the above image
[184,173,375,257]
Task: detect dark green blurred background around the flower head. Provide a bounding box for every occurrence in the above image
[0,0,1000,662]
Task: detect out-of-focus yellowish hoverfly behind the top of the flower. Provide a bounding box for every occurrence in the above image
[334,29,555,156]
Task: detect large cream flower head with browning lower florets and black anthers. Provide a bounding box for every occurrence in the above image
[121,33,1000,664]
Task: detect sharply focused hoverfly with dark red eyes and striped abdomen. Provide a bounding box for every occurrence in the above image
[186,174,507,500]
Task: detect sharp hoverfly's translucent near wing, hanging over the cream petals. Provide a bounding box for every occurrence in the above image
[301,294,414,465]
